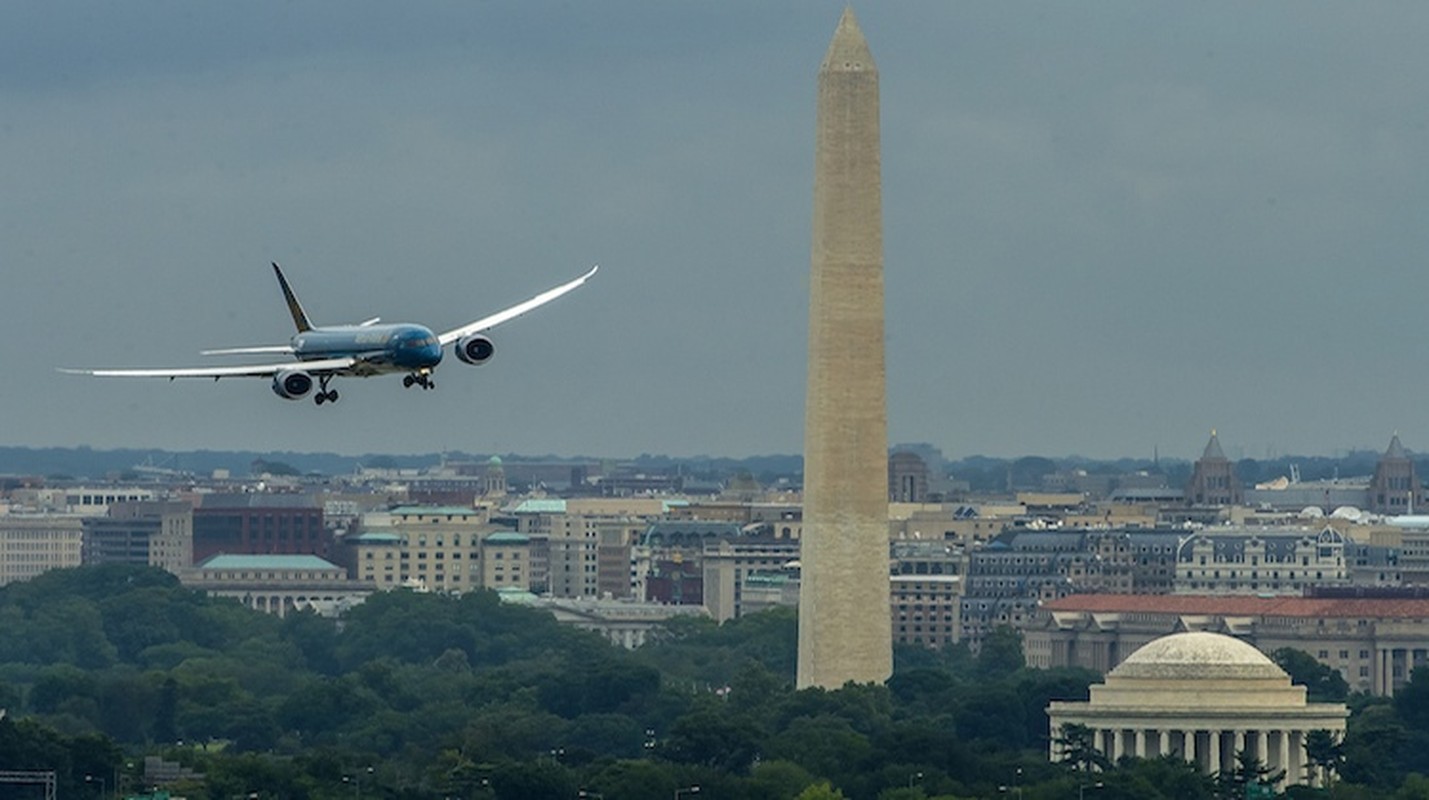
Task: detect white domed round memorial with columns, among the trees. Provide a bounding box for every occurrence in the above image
[1047,631,1349,783]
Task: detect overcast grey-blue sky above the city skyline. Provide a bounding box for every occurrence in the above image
[0,0,1429,459]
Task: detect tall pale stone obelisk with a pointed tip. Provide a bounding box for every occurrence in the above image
[799,9,893,689]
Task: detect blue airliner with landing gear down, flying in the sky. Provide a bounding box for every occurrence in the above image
[60,261,600,406]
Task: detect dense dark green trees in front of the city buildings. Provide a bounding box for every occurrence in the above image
[0,566,1429,800]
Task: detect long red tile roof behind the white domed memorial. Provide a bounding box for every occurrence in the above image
[1042,594,1429,619]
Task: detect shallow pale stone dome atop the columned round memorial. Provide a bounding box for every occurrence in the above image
[1110,631,1289,680]
